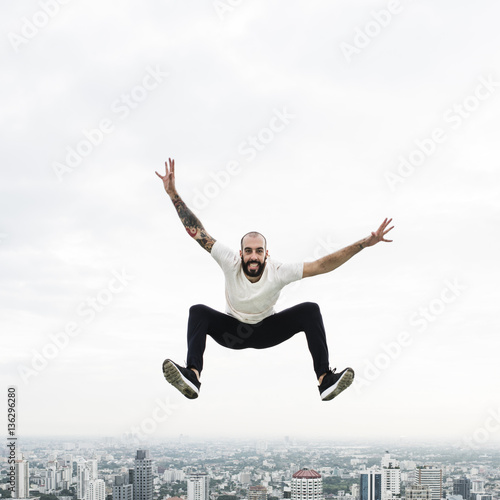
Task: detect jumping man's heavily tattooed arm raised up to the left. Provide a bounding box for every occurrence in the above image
[155,158,215,252]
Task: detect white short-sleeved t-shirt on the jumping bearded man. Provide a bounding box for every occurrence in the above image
[210,240,304,324]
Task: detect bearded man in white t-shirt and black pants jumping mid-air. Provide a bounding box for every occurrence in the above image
[156,159,394,401]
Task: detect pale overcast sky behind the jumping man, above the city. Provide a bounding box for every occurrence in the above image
[0,0,500,446]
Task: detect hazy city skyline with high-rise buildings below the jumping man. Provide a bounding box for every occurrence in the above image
[0,440,500,500]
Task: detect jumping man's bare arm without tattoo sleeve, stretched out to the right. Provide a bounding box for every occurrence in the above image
[302,219,394,278]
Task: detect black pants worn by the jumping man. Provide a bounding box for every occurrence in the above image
[187,302,329,378]
